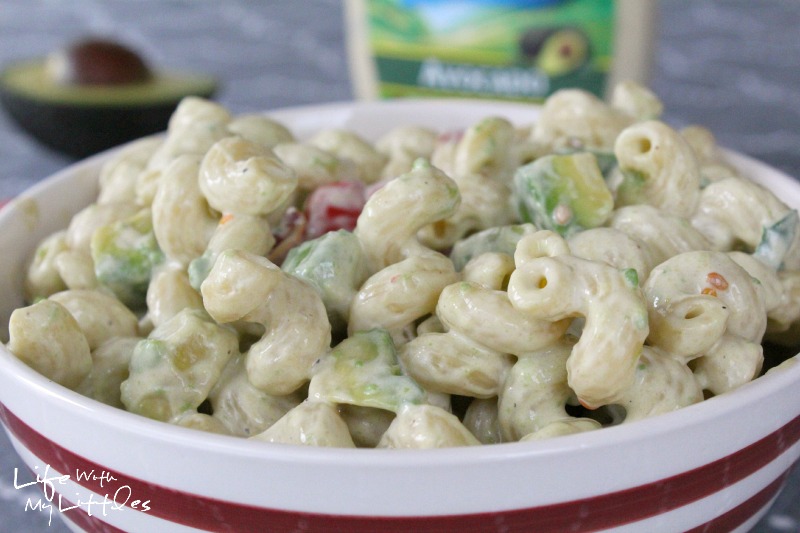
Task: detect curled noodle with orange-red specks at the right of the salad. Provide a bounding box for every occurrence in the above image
[643,251,767,394]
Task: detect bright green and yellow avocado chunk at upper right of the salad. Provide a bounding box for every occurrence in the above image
[514,152,614,237]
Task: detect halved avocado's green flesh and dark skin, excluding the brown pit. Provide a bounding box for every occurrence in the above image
[0,41,217,158]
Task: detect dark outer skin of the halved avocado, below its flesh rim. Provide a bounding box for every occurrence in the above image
[0,62,216,159]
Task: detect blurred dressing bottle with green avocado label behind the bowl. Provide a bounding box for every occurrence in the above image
[346,0,656,101]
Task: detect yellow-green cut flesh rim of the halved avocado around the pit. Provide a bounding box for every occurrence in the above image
[0,60,216,106]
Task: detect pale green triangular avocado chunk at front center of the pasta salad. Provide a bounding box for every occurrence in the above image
[308,329,426,413]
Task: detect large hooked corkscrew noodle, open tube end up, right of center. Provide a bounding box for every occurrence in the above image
[508,232,648,407]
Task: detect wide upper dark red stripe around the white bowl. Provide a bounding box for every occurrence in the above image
[0,403,800,533]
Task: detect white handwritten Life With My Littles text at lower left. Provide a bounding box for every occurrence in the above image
[14,465,150,524]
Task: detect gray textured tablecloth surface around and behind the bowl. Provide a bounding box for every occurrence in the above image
[0,0,800,533]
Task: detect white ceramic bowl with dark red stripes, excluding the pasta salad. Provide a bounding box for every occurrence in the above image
[0,101,800,533]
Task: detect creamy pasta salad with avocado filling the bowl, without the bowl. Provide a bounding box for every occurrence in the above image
[8,83,800,448]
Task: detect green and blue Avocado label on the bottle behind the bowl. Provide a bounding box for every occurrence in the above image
[367,0,614,101]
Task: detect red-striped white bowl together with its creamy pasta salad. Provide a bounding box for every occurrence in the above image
[0,83,800,532]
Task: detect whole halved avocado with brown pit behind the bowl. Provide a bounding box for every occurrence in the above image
[0,38,217,158]
